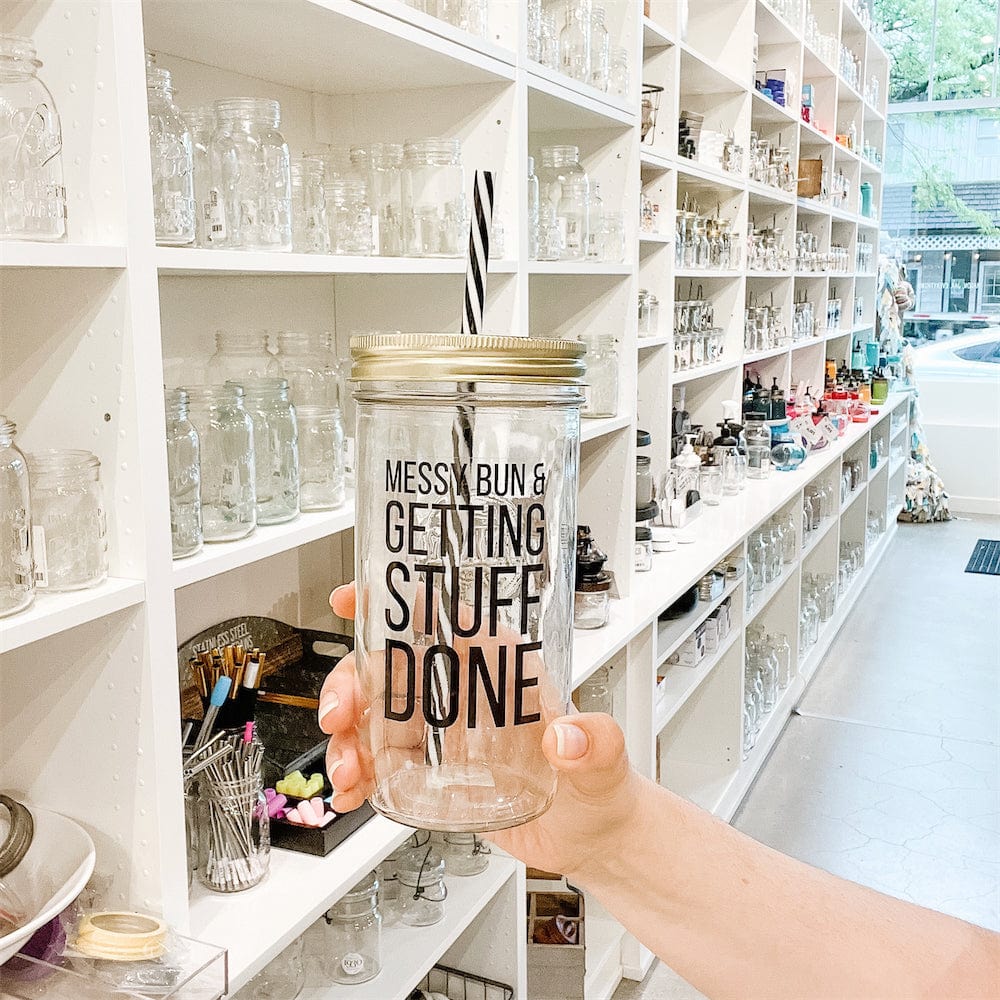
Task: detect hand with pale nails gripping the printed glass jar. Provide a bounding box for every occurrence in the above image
[319,584,643,879]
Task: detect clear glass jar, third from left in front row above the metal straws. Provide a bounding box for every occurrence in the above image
[230,378,299,524]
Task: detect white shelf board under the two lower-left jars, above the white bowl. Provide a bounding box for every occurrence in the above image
[0,577,146,653]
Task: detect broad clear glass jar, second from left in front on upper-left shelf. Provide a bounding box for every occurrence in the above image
[210,97,292,251]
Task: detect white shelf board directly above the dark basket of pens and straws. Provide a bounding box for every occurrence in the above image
[174,491,354,588]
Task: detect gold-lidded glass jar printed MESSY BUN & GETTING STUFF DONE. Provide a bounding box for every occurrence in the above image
[351,334,584,831]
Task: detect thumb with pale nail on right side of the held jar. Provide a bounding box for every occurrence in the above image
[542,713,629,796]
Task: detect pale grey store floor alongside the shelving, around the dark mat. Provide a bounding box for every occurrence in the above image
[614,517,1000,1000]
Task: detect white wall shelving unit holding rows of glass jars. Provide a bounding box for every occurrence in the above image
[0,0,892,1000]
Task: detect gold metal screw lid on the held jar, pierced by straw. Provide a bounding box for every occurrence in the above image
[351,333,586,385]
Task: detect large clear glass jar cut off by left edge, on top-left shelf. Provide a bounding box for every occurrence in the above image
[0,34,66,241]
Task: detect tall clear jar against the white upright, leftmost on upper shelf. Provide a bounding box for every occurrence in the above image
[146,65,194,247]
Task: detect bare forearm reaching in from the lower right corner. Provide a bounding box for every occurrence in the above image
[574,783,1000,1000]
